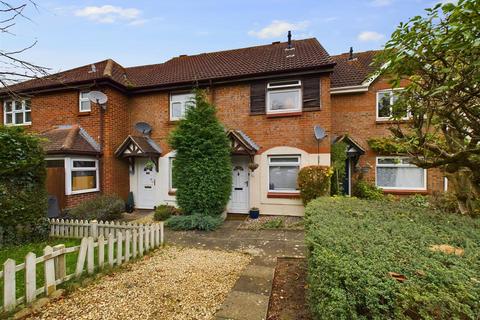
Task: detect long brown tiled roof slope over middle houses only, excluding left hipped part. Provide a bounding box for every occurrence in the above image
[126,38,334,87]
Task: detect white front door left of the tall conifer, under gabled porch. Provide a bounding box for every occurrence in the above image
[135,158,157,209]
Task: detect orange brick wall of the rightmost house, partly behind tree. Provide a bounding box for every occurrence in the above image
[332,79,443,192]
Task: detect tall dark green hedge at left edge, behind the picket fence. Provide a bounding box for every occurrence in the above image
[0,126,48,244]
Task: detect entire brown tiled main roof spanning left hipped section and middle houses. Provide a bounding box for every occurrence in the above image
[4,38,334,92]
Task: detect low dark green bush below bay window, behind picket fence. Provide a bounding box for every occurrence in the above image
[68,195,125,221]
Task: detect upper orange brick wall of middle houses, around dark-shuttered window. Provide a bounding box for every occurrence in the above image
[130,76,331,154]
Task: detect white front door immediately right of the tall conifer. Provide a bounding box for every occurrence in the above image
[228,156,250,213]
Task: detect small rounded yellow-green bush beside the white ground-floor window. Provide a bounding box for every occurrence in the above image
[298,166,332,205]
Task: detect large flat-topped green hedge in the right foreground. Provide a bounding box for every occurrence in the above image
[306,197,480,319]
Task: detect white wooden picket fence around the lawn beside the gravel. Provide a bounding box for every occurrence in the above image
[0,222,164,311]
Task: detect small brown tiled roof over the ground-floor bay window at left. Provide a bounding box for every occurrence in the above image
[41,125,100,154]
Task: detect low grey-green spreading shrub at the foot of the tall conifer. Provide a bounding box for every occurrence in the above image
[165,214,223,231]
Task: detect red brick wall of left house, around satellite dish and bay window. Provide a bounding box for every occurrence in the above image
[1,88,130,207]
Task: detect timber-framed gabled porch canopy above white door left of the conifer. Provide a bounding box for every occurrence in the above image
[115,135,162,173]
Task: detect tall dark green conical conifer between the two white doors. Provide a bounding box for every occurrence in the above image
[169,90,232,229]
